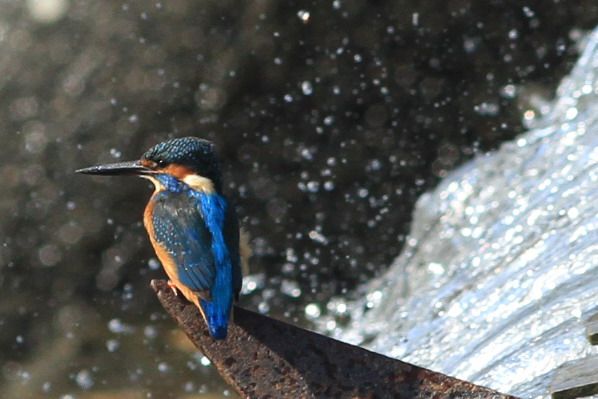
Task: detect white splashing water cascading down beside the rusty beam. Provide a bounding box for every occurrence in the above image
[323,30,598,398]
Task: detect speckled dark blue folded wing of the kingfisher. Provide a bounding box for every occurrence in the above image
[152,193,216,300]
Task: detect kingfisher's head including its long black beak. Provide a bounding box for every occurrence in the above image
[77,137,222,192]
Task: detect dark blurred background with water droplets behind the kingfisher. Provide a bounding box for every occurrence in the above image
[0,0,598,398]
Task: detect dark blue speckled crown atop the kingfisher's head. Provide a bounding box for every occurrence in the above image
[141,137,222,191]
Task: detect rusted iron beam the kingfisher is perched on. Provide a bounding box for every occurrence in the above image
[152,280,514,399]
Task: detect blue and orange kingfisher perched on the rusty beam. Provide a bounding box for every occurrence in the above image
[76,137,249,339]
